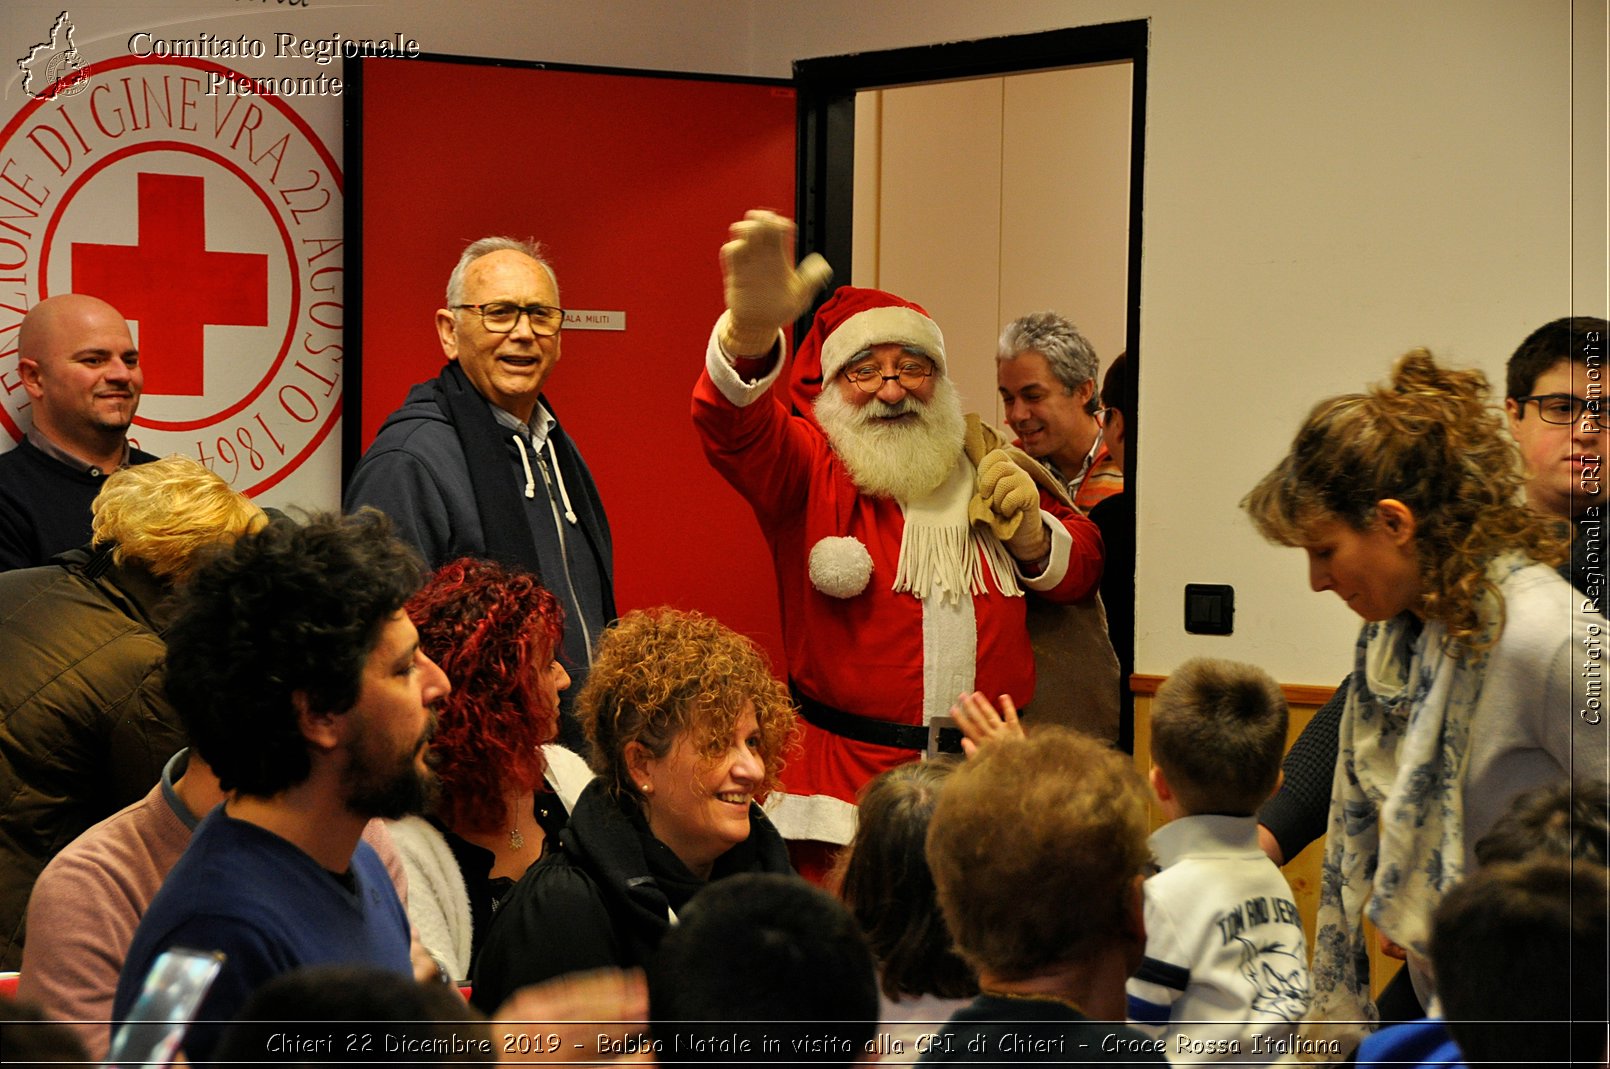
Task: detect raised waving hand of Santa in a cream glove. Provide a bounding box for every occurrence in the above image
[721,211,832,357]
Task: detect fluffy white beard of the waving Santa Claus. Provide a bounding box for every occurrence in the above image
[813,375,966,501]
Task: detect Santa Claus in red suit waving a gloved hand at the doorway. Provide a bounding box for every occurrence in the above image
[694,211,1101,869]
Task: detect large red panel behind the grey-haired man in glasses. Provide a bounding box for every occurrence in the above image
[359,60,795,675]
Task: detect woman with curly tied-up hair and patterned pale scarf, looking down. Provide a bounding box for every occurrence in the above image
[1241,349,1605,1043]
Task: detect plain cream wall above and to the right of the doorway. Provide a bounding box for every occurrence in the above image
[0,0,1610,684]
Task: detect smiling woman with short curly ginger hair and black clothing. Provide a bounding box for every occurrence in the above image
[475,609,797,1008]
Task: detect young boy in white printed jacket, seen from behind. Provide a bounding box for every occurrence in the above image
[1127,658,1309,1063]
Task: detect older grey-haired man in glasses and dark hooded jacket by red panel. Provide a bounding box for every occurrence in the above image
[345,237,615,750]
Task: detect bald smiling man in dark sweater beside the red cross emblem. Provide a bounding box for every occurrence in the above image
[0,293,156,572]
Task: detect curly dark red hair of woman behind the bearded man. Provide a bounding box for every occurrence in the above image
[407,557,565,834]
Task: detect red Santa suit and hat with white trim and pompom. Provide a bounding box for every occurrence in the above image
[692,287,1101,844]
